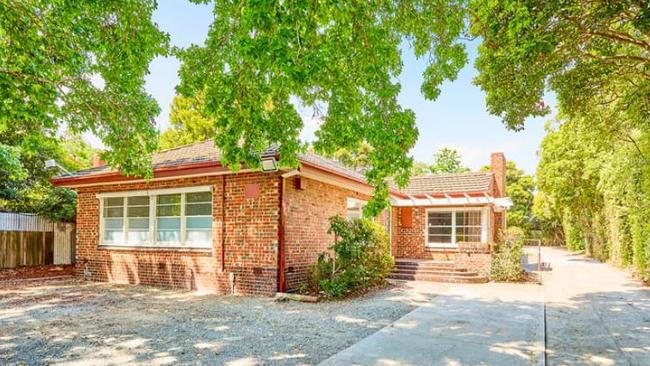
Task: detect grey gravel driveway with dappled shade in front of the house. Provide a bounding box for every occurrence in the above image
[0,280,429,365]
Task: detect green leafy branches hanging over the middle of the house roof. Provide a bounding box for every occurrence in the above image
[176,0,467,214]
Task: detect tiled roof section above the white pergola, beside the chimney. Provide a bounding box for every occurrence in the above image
[398,172,492,195]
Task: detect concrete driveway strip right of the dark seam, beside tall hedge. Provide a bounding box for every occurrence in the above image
[542,248,650,366]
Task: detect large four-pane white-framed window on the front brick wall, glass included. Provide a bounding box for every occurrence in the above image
[97,186,212,248]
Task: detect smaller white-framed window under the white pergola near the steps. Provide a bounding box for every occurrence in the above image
[425,207,487,247]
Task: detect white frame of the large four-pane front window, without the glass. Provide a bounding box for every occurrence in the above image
[96,186,214,250]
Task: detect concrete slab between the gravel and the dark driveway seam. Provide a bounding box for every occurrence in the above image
[321,282,544,366]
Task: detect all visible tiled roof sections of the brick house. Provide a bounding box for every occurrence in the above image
[65,140,492,195]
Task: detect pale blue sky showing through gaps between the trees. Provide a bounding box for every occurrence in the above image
[98,0,553,174]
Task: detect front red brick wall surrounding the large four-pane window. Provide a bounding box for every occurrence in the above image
[75,173,279,295]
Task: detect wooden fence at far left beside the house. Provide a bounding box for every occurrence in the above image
[0,212,75,268]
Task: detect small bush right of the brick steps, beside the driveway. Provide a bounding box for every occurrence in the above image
[492,226,524,281]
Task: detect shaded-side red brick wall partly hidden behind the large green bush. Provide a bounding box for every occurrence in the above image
[283,177,370,290]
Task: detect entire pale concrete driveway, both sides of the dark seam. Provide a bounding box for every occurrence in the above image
[321,248,650,366]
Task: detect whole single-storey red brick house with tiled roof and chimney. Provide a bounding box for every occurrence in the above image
[52,141,505,295]
